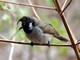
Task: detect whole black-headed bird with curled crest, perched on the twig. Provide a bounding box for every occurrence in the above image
[17,16,68,45]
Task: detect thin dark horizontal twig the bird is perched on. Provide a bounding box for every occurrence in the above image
[0,39,71,47]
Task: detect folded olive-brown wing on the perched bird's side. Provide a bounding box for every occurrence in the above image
[39,23,59,35]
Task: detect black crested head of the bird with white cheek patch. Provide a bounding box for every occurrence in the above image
[17,16,35,33]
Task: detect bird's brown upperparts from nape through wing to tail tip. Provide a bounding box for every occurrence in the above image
[34,18,68,42]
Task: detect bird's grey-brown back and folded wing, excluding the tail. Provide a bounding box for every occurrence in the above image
[33,17,59,35]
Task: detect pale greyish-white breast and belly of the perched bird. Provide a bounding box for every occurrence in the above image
[27,27,50,44]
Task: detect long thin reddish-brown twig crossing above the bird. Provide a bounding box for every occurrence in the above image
[0,0,56,10]
